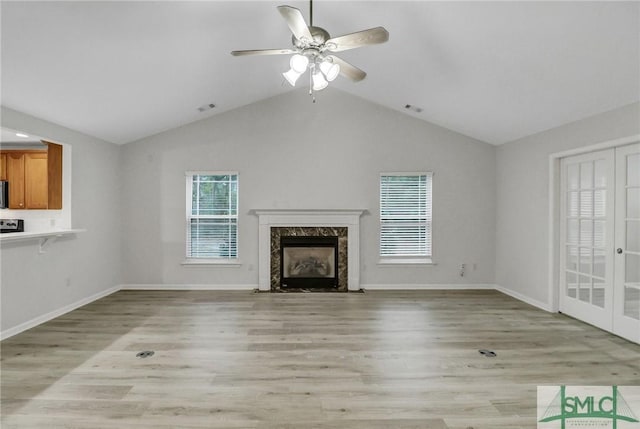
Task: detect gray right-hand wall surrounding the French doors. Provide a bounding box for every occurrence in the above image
[496,103,640,304]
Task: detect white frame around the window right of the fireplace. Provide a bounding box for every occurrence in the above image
[378,171,436,265]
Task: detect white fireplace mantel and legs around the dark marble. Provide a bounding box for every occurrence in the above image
[251,209,366,292]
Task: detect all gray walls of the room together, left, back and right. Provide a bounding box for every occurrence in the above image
[0,89,640,331]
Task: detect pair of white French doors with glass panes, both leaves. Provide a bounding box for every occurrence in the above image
[560,144,640,342]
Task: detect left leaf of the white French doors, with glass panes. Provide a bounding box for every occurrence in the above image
[560,150,615,331]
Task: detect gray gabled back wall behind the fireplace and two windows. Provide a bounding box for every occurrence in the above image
[120,88,495,287]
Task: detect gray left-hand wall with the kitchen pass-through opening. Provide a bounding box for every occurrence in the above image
[0,107,121,331]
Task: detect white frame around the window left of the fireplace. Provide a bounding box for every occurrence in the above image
[181,170,242,267]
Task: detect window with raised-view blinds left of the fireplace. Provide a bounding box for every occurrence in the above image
[187,172,238,260]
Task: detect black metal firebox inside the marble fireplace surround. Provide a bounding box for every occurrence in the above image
[280,236,338,289]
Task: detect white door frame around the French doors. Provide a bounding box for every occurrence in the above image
[546,134,640,313]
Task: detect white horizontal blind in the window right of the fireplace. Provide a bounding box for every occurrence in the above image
[380,173,432,258]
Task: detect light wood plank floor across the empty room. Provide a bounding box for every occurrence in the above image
[1,291,640,429]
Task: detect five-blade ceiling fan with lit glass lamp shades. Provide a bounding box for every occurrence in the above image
[231,0,389,92]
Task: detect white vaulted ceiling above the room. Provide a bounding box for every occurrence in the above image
[1,0,640,144]
